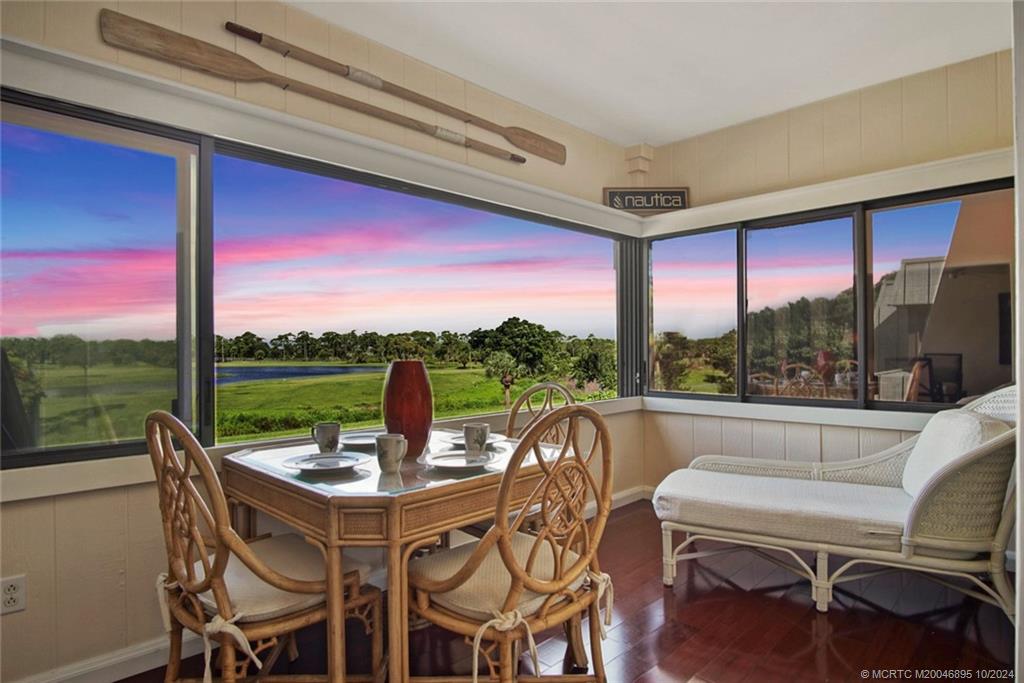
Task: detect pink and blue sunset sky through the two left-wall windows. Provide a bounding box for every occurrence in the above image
[0,123,615,339]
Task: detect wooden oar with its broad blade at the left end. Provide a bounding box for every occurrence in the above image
[99,9,526,164]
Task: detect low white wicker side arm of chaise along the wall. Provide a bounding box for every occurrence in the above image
[690,437,916,486]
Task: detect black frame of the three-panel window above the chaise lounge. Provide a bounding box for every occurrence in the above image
[644,176,1014,413]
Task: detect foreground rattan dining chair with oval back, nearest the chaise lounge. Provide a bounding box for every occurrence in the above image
[409,404,611,683]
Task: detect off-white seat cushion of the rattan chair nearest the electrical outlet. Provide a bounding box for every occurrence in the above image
[197,533,370,622]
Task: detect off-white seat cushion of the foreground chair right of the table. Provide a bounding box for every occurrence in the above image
[409,533,586,623]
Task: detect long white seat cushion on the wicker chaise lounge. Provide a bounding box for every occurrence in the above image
[654,469,912,550]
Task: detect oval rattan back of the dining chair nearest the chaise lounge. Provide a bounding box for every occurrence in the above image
[489,404,611,612]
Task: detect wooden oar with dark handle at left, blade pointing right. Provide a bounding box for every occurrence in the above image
[224,22,565,165]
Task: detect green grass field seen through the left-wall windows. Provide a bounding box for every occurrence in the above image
[19,361,552,446]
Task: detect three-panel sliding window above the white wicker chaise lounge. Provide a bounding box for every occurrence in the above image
[648,181,1014,410]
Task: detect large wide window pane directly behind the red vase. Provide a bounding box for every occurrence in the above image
[214,155,616,441]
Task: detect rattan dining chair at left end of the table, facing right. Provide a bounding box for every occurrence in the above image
[145,411,384,683]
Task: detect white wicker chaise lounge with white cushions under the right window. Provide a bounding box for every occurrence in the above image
[654,386,1017,620]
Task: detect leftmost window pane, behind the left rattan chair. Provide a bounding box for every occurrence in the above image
[0,105,197,455]
